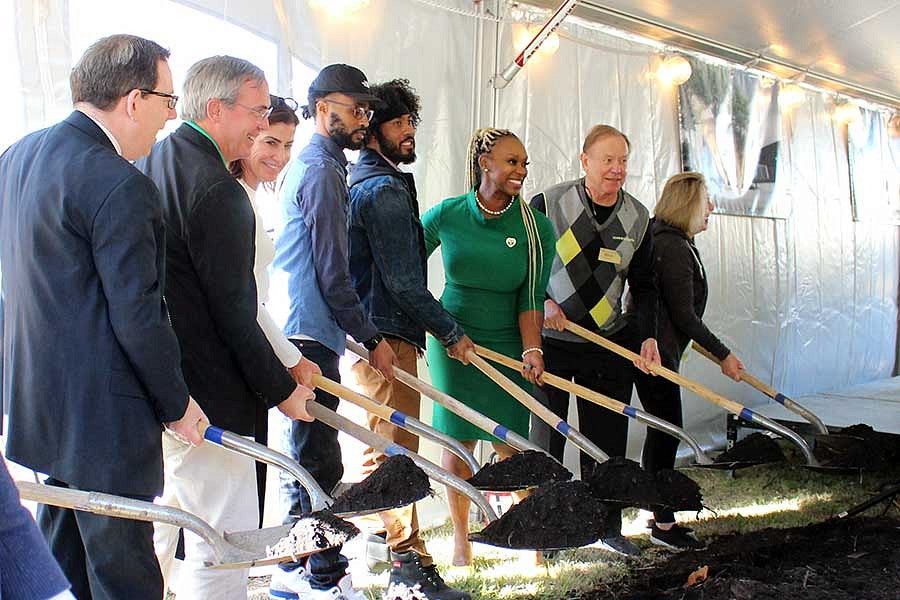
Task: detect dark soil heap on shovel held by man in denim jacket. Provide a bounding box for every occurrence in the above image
[585,456,666,509]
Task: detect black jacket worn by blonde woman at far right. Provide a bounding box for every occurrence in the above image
[628,218,731,369]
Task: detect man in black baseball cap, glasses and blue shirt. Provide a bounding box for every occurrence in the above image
[269,64,396,600]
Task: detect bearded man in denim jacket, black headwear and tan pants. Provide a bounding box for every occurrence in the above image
[350,79,474,600]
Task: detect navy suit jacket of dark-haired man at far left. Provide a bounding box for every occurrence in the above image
[0,111,187,496]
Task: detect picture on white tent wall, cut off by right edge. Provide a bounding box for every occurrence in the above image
[847,108,900,225]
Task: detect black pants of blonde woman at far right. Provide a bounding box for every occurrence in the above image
[634,356,684,523]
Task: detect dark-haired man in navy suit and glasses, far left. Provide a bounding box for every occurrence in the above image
[0,35,206,600]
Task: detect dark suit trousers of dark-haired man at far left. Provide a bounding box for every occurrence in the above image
[37,478,163,600]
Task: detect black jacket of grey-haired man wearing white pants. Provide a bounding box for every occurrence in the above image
[137,124,296,435]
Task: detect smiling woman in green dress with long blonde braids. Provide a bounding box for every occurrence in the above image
[422,129,556,565]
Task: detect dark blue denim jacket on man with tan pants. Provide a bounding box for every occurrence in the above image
[350,148,463,348]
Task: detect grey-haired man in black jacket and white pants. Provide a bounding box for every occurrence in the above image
[138,56,318,600]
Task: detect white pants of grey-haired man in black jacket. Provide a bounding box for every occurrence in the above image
[153,434,259,600]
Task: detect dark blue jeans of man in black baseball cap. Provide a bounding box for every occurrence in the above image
[280,340,348,590]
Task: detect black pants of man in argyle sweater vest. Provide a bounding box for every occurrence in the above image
[529,325,642,537]
